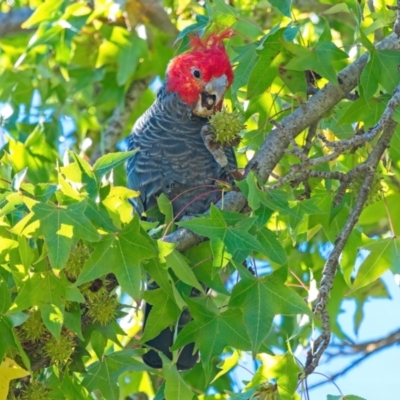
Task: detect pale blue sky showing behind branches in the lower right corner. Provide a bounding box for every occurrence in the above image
[309,272,400,400]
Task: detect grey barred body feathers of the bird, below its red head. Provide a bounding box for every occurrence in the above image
[127,87,236,217]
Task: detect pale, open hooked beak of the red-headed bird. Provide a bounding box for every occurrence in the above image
[193,75,228,117]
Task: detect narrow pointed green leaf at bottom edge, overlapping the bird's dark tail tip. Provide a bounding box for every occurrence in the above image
[160,354,194,400]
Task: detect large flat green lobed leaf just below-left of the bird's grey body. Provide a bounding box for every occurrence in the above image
[76,218,156,298]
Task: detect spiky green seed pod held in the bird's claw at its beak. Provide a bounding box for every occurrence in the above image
[209,107,246,146]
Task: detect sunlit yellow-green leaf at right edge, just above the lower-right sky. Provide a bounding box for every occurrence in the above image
[353,238,400,290]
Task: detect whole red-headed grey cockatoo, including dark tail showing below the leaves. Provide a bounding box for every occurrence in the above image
[127,30,236,369]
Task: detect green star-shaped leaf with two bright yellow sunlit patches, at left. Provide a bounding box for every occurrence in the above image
[13,201,99,268]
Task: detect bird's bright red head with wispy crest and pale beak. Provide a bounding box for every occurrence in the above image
[166,30,233,117]
